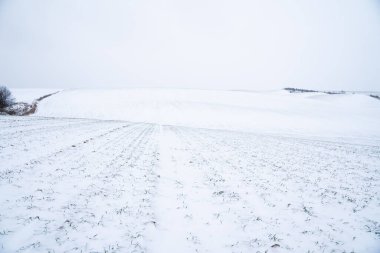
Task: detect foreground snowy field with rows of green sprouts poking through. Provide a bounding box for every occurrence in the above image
[0,117,380,252]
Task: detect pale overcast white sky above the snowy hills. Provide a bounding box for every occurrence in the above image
[0,0,380,90]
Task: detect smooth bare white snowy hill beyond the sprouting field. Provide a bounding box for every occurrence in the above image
[32,89,380,138]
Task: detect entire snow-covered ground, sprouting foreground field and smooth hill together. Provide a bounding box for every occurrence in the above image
[0,89,380,253]
